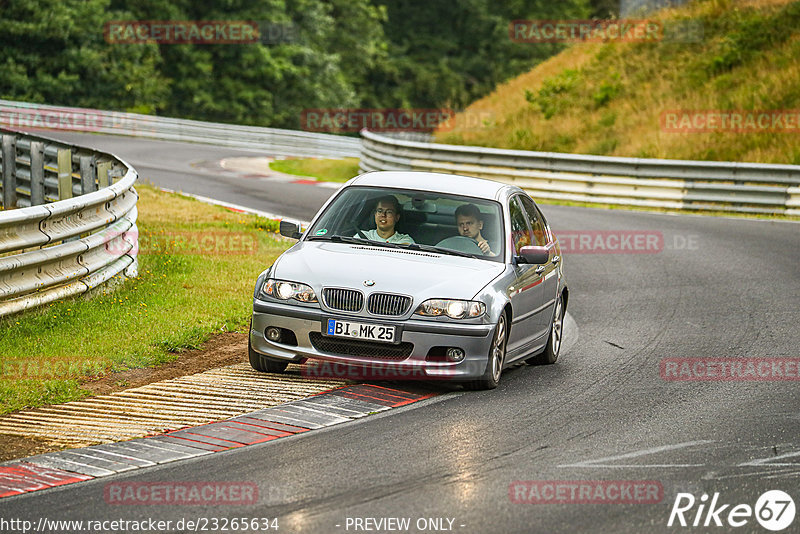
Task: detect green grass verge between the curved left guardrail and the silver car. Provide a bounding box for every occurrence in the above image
[0,185,288,414]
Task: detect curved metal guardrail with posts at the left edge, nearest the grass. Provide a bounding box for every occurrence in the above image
[0,130,138,317]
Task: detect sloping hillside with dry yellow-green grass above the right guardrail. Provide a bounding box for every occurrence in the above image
[437,0,800,164]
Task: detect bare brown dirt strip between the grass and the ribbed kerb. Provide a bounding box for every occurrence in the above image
[0,332,247,462]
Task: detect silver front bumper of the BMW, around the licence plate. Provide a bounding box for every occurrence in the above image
[250,299,494,381]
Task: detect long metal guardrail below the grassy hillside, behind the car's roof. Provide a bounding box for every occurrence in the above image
[359,131,800,215]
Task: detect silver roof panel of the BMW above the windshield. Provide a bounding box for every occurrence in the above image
[349,171,518,199]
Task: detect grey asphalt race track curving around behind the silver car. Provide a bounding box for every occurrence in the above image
[0,134,800,533]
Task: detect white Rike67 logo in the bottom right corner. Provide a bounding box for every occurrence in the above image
[667,490,796,532]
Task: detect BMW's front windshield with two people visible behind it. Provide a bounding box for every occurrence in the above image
[306,186,504,262]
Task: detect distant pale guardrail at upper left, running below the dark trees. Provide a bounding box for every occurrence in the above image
[0,100,361,158]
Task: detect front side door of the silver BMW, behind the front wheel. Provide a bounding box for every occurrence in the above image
[508,195,546,358]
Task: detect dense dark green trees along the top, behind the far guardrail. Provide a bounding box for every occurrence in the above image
[0,0,597,128]
